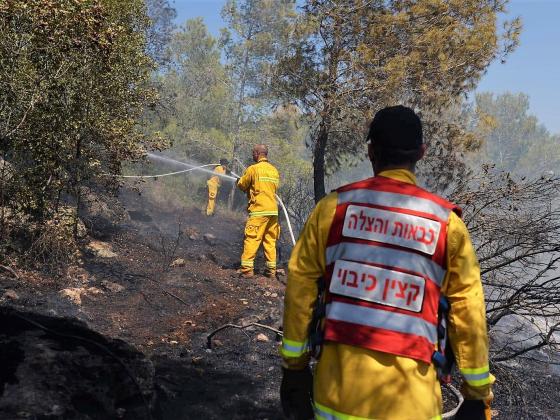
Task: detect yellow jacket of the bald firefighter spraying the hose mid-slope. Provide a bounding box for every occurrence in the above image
[237,158,280,217]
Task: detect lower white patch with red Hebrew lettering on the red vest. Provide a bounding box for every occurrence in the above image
[329,260,426,312]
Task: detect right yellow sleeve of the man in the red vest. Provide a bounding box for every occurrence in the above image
[442,213,495,404]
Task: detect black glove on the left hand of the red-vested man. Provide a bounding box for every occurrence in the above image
[280,366,313,420]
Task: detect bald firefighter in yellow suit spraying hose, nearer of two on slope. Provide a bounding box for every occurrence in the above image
[237,144,280,277]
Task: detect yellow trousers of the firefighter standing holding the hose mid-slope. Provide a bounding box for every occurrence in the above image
[241,216,280,274]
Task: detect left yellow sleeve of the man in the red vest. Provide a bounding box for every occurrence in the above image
[280,193,337,369]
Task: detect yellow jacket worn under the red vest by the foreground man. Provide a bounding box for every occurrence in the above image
[280,169,494,420]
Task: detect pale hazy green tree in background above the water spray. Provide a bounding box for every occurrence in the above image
[149,18,234,162]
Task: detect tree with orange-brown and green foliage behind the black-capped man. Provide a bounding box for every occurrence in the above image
[275,0,520,200]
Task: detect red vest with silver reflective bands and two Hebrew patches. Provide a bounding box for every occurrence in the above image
[324,176,461,363]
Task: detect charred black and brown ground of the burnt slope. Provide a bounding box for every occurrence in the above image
[0,188,560,420]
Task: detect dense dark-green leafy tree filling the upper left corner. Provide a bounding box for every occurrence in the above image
[0,0,160,235]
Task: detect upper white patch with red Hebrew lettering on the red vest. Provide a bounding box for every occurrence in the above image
[342,205,441,255]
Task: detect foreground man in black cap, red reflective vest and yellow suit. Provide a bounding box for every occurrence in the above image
[280,106,494,420]
